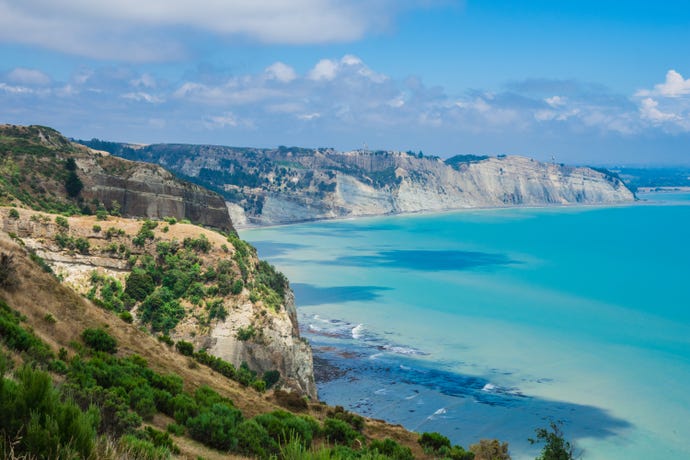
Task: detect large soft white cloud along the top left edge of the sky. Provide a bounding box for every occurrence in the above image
[0,0,414,61]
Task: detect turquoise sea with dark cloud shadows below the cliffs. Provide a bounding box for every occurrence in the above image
[240,193,690,460]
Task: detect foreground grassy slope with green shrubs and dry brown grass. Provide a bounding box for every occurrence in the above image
[0,228,440,459]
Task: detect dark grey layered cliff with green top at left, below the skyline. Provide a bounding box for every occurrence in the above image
[0,125,234,232]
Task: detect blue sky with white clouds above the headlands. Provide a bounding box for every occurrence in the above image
[0,0,690,165]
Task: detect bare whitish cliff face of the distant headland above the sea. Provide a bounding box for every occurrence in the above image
[251,154,635,225]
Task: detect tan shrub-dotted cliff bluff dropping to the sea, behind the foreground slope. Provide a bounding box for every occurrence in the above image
[0,208,316,398]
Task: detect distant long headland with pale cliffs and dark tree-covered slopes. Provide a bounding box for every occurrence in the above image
[79,139,635,226]
